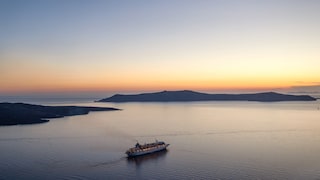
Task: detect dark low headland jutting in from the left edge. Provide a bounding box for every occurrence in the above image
[0,103,119,126]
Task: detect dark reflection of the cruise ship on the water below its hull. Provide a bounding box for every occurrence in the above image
[127,149,168,166]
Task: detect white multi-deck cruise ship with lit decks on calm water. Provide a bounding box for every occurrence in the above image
[126,140,169,157]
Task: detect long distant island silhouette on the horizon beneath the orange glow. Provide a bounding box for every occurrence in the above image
[97,90,316,102]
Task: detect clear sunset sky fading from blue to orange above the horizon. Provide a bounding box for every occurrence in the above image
[0,0,320,95]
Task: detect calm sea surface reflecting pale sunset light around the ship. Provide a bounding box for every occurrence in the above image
[0,102,320,179]
